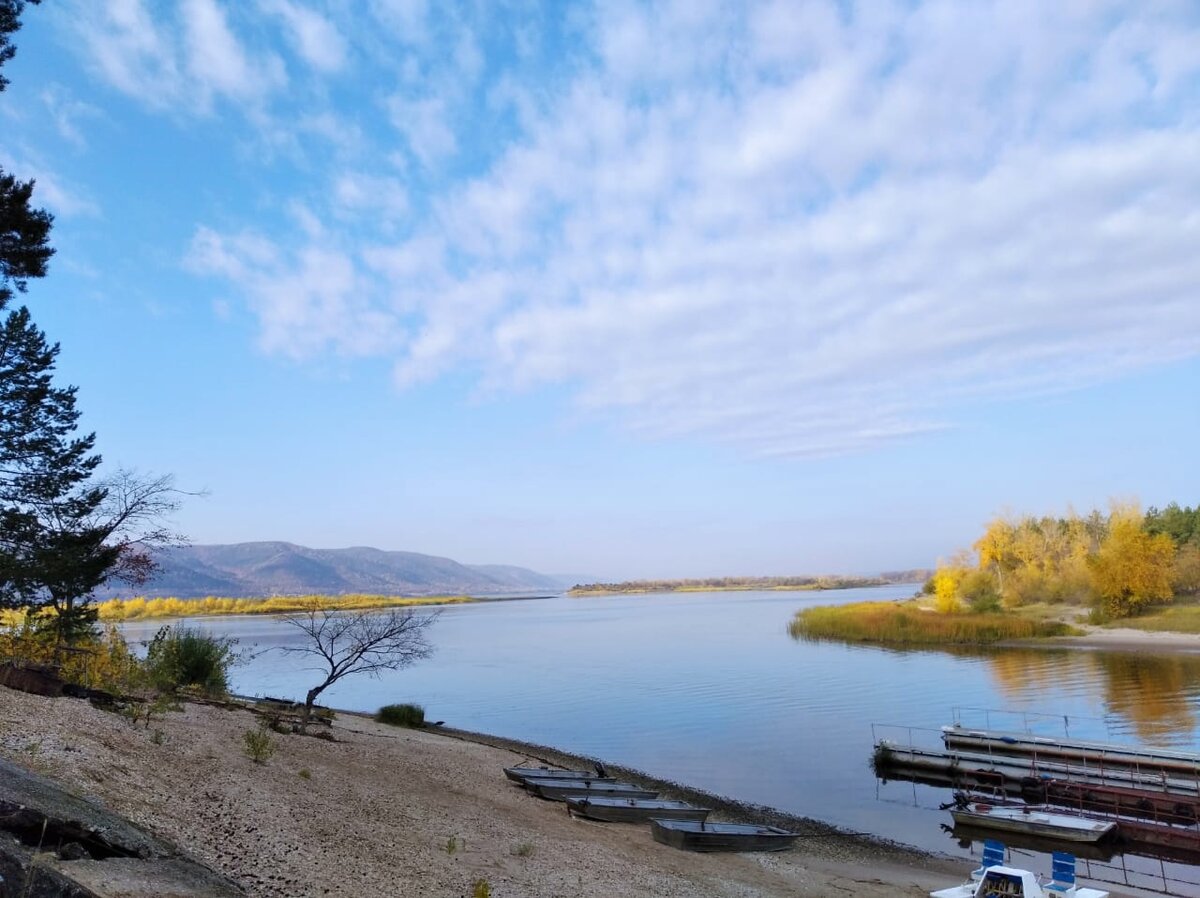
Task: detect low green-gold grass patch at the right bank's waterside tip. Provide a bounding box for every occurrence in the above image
[788,601,1073,645]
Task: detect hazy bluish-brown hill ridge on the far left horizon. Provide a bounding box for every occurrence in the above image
[97,543,570,599]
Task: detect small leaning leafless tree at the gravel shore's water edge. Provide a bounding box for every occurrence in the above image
[281,600,440,723]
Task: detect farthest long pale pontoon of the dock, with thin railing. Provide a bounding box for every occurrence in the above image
[942,724,1200,778]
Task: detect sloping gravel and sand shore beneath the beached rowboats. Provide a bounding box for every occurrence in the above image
[0,688,965,898]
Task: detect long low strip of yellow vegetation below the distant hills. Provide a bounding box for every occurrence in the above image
[96,594,474,621]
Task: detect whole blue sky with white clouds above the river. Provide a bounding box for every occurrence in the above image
[0,0,1200,579]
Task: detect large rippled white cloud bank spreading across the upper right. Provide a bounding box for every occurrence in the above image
[184,0,1200,454]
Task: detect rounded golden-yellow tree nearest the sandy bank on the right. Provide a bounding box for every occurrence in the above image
[1091,505,1175,617]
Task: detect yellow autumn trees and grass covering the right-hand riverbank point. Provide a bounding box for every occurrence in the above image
[790,503,1200,645]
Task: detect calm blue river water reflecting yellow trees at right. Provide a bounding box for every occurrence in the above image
[119,586,1200,888]
